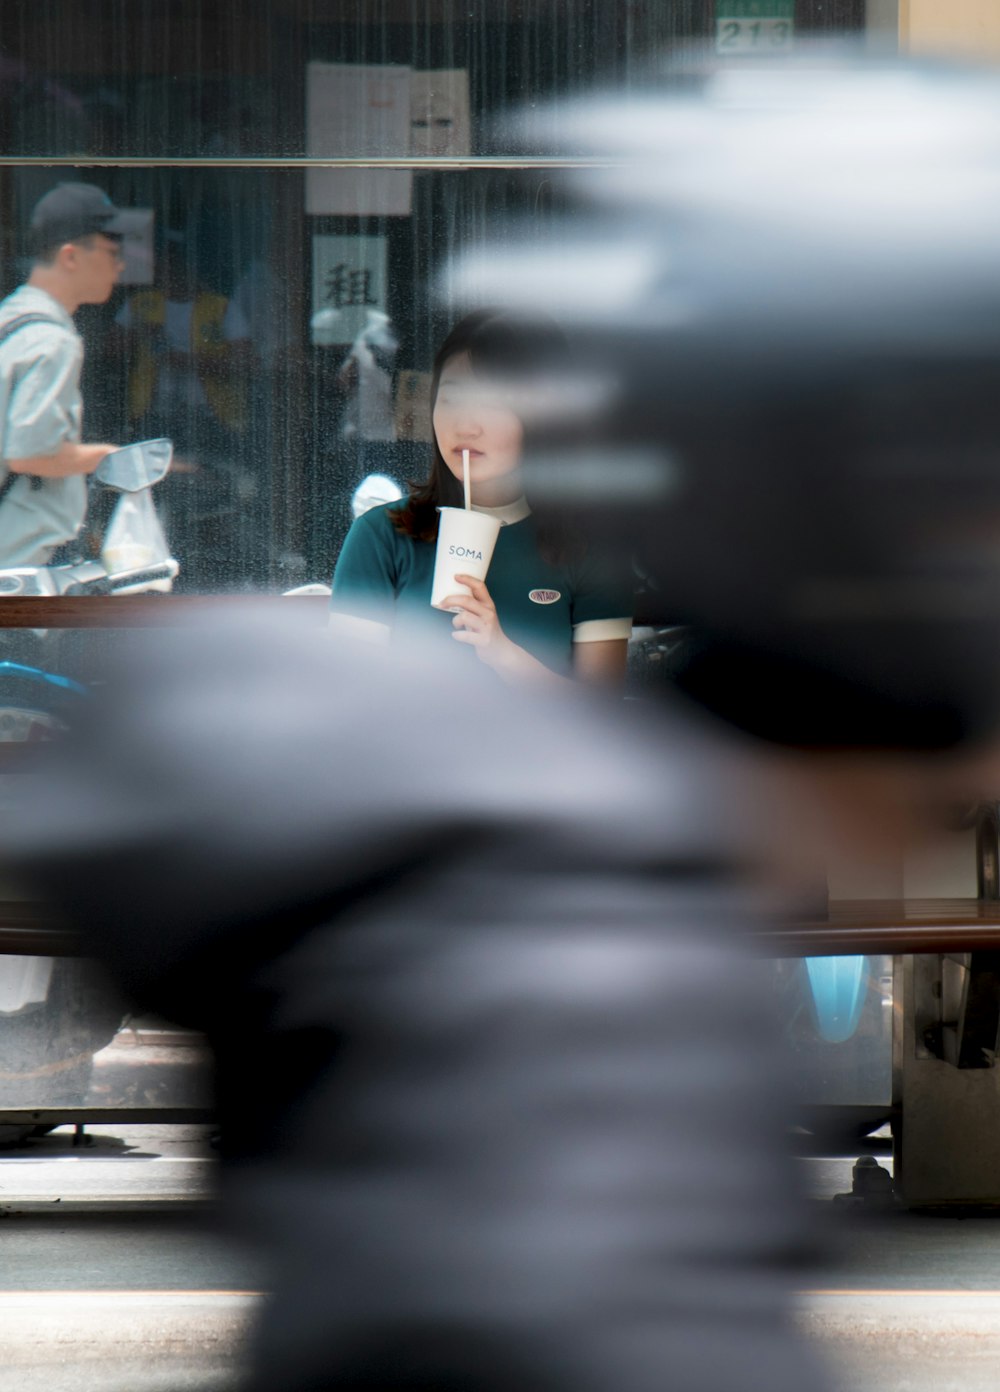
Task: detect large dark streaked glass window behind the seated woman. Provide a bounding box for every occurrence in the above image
[0,0,864,592]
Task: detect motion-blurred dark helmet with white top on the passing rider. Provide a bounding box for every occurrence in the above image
[462,54,1000,752]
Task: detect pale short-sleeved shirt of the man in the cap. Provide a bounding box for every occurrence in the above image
[0,285,86,567]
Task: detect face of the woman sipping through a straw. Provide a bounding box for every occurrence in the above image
[433,354,524,496]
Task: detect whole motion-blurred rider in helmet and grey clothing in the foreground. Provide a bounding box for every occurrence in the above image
[8,49,1000,1392]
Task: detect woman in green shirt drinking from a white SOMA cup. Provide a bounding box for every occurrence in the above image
[331,310,632,685]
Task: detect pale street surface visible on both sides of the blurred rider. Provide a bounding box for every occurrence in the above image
[0,1126,1000,1392]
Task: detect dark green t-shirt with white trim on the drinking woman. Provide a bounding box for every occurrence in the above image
[331,503,632,672]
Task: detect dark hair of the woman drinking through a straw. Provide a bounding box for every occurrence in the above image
[390,309,570,553]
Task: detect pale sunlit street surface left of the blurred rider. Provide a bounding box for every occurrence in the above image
[0,1126,263,1392]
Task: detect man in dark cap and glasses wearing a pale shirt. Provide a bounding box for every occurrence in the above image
[0,184,124,567]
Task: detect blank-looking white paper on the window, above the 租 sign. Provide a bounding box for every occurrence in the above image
[305,63,412,217]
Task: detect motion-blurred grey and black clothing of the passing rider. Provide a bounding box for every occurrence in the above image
[7,619,822,1392]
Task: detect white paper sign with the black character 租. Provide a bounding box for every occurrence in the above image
[309,235,389,347]
